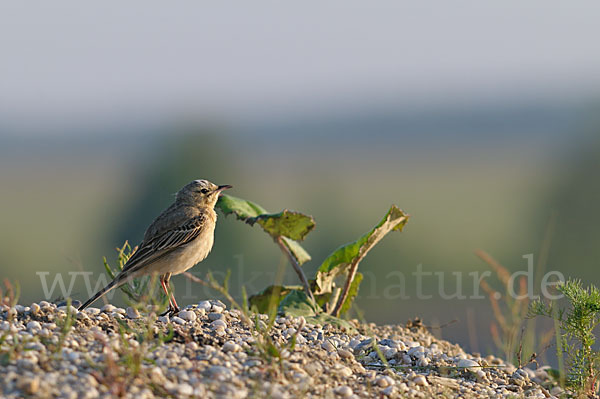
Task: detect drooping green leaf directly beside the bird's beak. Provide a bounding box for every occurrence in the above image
[216,194,315,265]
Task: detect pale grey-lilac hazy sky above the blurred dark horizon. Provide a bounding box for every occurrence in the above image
[0,0,600,133]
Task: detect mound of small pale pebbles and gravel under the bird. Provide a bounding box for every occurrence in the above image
[0,300,562,399]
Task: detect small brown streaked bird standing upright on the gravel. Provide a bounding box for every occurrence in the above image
[79,179,232,314]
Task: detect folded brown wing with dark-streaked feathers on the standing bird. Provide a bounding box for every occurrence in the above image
[122,214,206,274]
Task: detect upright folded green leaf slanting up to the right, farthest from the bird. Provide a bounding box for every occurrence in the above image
[315,205,409,295]
